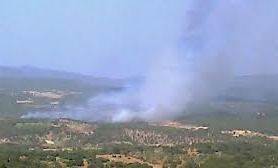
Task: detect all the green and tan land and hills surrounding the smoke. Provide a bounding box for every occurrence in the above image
[0,67,278,168]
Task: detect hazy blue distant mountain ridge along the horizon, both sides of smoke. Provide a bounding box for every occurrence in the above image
[0,66,278,102]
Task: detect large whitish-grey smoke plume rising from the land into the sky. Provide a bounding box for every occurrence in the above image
[22,0,278,122]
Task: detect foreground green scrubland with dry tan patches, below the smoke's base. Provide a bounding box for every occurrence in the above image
[0,119,278,168]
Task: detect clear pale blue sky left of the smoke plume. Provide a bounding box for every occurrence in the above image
[0,0,187,76]
